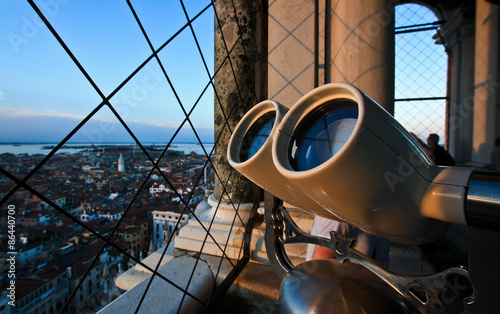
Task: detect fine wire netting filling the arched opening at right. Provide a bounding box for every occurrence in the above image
[394,4,448,143]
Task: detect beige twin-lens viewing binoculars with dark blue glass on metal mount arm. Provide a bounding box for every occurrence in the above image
[228,83,500,312]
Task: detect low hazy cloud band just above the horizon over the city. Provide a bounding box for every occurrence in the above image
[0,108,213,143]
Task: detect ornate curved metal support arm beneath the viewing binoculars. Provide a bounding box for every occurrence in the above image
[265,199,476,313]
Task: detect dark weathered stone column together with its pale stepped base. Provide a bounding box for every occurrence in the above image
[175,0,267,259]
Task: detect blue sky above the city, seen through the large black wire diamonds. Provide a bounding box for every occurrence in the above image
[0,0,214,142]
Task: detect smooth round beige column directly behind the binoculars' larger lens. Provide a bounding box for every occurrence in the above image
[325,0,394,114]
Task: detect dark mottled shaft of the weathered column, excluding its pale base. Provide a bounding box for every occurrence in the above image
[213,0,258,203]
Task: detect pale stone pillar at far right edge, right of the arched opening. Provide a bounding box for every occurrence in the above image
[472,0,500,166]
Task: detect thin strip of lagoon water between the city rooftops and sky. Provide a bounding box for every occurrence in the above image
[0,143,214,155]
